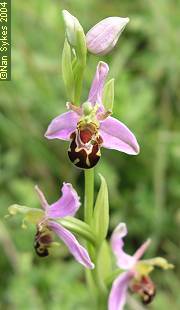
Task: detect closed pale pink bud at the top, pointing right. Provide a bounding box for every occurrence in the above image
[86,17,129,55]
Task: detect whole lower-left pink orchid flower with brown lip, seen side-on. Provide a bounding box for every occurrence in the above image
[9,183,94,269]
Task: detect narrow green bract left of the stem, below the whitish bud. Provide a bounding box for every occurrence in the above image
[62,39,75,102]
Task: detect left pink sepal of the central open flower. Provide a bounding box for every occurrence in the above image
[45,111,79,141]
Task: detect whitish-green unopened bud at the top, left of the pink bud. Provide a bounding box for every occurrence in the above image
[62,10,84,47]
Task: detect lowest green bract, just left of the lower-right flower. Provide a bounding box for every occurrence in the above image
[96,240,112,290]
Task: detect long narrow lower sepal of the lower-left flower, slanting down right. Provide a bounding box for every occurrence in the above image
[48,221,94,269]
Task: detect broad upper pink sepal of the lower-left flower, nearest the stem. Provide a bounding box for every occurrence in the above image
[47,183,80,218]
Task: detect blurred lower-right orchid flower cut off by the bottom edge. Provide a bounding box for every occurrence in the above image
[108,223,173,310]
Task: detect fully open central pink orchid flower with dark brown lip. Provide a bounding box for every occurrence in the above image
[45,61,139,169]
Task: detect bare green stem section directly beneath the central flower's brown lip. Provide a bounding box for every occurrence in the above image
[84,168,94,225]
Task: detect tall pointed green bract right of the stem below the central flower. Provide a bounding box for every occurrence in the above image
[92,174,109,244]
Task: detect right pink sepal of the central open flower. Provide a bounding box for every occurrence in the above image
[99,116,139,155]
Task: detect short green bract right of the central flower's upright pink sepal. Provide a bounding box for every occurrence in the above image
[103,79,114,112]
